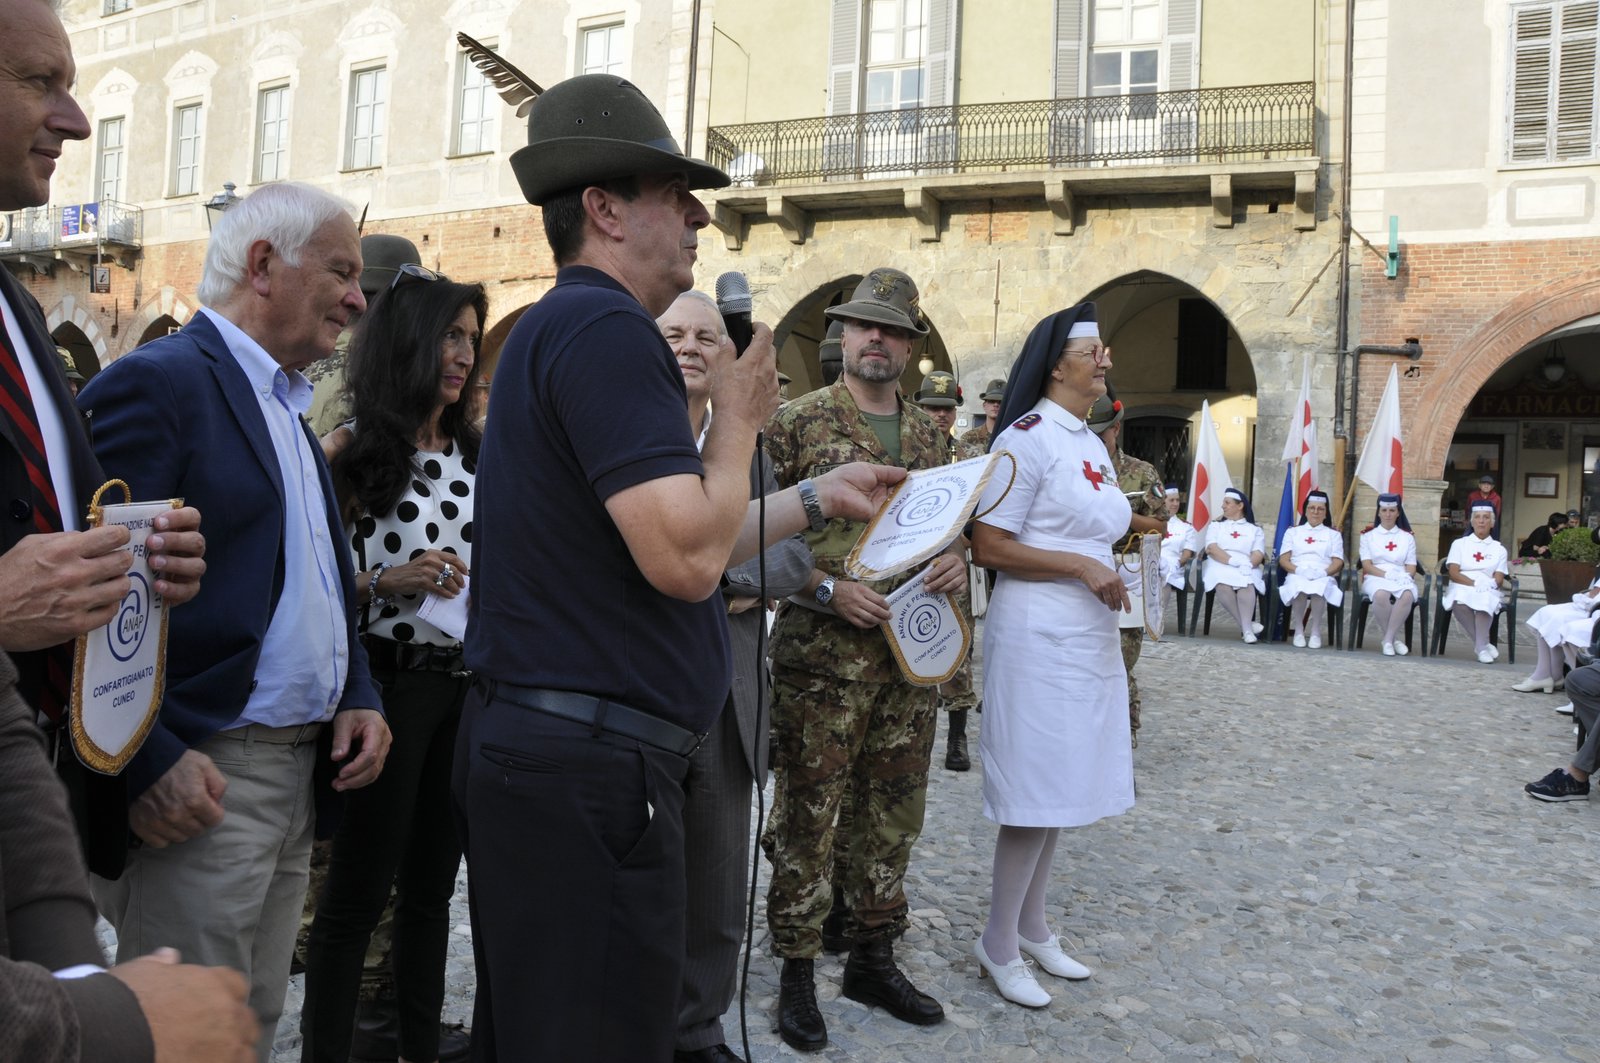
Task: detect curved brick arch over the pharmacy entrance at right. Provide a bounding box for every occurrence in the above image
[1406,269,1600,475]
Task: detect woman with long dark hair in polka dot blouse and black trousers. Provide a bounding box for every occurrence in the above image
[301,266,488,1063]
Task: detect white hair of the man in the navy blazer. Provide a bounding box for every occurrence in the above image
[195,181,354,306]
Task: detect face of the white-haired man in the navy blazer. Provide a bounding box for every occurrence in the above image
[260,215,366,370]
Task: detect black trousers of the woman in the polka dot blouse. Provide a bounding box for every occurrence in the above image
[301,668,470,1063]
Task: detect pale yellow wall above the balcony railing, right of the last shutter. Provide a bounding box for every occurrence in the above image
[1200,0,1322,88]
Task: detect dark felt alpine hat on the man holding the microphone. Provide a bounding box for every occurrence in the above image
[510,74,733,207]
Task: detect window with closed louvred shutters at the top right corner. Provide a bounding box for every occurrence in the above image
[1506,0,1600,166]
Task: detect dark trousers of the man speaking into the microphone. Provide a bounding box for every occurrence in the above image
[453,682,688,1063]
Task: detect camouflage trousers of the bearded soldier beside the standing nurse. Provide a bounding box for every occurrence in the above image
[762,669,936,959]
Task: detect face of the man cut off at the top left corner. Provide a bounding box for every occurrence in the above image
[0,0,90,210]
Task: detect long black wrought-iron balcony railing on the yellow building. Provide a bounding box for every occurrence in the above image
[706,82,1317,186]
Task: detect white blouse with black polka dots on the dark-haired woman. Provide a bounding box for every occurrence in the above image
[349,442,477,647]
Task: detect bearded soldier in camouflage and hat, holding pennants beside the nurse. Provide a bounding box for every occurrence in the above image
[762,269,966,1052]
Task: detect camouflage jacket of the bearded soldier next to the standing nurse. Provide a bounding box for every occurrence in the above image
[766,378,949,684]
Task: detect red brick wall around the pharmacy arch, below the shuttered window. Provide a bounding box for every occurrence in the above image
[1350,237,1600,479]
